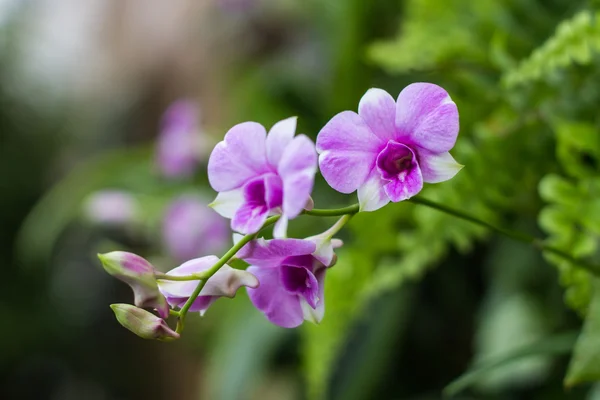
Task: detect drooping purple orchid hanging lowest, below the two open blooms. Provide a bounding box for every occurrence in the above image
[238,237,341,328]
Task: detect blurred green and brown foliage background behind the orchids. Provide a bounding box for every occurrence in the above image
[0,0,600,400]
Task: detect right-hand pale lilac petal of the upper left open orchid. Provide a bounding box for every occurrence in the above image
[277,135,317,219]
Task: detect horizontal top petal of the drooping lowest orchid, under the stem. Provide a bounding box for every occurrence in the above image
[237,239,316,268]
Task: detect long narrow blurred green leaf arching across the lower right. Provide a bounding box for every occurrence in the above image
[444,332,577,396]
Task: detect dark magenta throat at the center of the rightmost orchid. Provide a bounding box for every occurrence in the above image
[377,140,418,182]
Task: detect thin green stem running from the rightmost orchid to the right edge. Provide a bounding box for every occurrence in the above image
[409,196,600,275]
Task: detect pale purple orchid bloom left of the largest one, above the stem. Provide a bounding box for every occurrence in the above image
[208,118,317,237]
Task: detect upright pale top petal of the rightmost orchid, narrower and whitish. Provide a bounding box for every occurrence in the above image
[358,88,396,142]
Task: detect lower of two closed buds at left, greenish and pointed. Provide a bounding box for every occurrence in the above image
[110,304,179,340]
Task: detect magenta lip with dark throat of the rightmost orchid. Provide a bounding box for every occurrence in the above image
[377,141,423,202]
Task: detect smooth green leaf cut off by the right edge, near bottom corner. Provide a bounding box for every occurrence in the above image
[564,278,600,387]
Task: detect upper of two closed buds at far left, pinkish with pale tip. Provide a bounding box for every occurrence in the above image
[98,251,169,318]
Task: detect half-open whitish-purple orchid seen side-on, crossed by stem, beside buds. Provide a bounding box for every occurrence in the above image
[158,256,259,315]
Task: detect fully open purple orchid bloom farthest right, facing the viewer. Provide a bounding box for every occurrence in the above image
[317,83,462,211]
